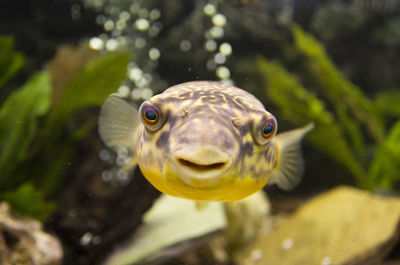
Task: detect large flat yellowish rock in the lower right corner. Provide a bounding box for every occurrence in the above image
[235,187,400,265]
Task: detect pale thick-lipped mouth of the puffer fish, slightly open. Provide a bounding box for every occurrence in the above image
[172,146,232,188]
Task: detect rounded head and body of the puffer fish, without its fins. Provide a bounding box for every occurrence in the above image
[136,82,277,201]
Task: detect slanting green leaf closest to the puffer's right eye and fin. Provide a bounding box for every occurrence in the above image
[257,58,365,186]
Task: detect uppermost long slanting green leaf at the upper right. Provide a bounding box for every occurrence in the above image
[292,26,384,144]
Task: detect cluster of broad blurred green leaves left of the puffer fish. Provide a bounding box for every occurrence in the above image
[0,37,130,220]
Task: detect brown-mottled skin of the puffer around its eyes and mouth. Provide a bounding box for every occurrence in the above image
[136,81,276,200]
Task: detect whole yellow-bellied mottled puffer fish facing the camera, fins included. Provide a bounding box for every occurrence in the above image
[99,81,313,202]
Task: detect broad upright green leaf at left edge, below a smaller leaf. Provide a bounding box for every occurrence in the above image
[0,71,51,185]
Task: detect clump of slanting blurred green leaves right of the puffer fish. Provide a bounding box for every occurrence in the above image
[258,26,400,190]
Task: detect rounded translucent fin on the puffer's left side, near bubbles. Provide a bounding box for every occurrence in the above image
[99,94,140,154]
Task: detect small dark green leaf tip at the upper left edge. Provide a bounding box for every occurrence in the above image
[0,36,25,87]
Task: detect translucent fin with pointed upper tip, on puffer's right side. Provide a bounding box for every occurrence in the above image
[269,123,314,190]
